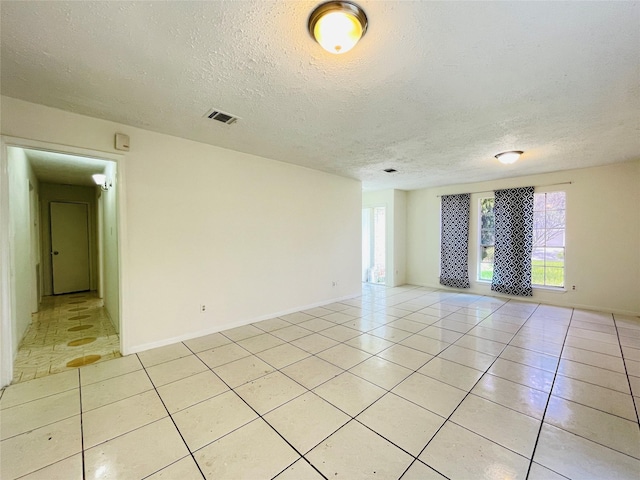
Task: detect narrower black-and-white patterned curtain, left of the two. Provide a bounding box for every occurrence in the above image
[440,193,471,288]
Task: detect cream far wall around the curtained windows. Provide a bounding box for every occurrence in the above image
[407,161,640,315]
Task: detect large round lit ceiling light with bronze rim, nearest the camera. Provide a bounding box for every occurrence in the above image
[309,2,367,54]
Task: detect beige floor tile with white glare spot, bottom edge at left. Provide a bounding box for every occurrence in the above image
[84,418,189,480]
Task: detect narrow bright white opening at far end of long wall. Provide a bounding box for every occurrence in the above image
[362,207,387,284]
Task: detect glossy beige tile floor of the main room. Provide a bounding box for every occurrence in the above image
[0,286,640,480]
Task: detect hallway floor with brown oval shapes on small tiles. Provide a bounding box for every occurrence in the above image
[12,292,121,383]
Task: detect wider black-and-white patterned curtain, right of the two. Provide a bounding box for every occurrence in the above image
[491,187,533,297]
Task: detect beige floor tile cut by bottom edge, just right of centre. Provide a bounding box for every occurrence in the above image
[306,421,413,480]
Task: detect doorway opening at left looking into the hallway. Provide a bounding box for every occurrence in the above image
[0,139,121,384]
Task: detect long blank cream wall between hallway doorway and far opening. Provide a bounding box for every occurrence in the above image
[1,97,361,353]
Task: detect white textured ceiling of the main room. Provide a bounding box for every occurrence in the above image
[0,0,640,190]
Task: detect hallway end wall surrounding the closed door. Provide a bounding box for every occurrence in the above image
[40,183,98,295]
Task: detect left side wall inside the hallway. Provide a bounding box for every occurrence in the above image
[7,148,38,357]
